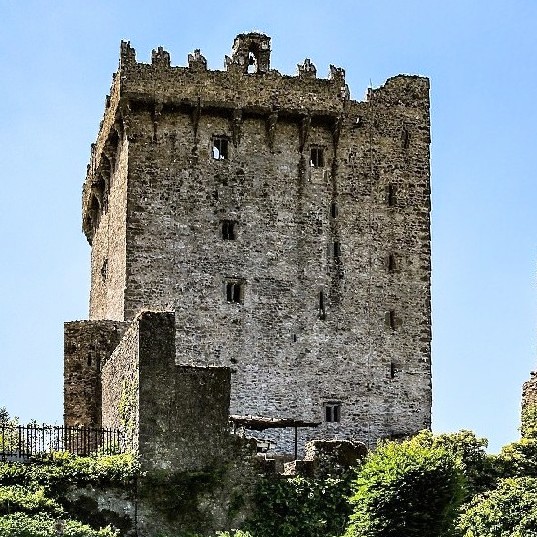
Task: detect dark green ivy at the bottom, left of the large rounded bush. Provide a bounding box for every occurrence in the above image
[246,471,355,537]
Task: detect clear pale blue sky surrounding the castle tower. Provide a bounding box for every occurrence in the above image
[0,0,537,451]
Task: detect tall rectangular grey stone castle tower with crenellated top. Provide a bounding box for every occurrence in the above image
[65,33,431,451]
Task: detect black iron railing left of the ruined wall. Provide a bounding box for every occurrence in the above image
[0,424,128,461]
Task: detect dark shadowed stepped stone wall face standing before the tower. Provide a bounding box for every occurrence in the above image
[138,312,230,472]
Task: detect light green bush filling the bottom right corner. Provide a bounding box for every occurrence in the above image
[458,477,537,537]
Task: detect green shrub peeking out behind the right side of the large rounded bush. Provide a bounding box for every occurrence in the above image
[413,430,498,497]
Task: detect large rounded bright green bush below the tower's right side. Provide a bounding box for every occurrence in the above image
[346,439,465,537]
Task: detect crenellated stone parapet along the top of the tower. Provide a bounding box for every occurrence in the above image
[82,33,429,243]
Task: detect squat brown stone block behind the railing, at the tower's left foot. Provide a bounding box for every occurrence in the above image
[64,321,126,427]
